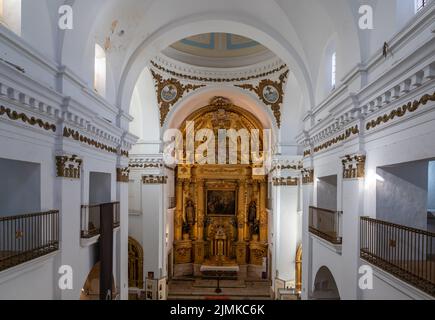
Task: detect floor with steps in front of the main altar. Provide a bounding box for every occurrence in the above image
[168,279,270,300]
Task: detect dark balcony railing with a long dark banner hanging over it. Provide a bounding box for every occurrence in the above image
[81,202,121,239]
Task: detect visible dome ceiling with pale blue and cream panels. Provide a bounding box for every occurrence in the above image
[163,33,274,68]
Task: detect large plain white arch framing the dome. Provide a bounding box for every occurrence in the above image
[118,12,314,117]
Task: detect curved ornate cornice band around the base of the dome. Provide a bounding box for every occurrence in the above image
[151,61,287,83]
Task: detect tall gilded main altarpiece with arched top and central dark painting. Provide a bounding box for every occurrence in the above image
[174,97,268,279]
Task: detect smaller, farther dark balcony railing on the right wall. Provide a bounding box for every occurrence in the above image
[309,207,343,245]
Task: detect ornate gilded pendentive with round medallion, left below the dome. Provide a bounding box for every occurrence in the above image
[151,70,205,127]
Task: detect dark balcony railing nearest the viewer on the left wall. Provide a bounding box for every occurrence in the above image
[0,211,59,271]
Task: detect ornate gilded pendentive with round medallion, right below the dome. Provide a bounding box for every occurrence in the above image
[236,70,289,128]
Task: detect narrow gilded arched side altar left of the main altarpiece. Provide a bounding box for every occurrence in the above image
[128,237,144,289]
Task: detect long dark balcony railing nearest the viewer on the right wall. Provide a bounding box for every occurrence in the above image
[360,217,435,296]
